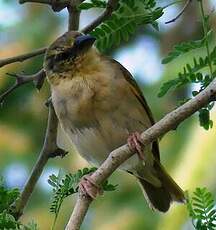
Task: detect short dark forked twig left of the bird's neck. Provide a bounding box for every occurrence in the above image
[0,69,46,104]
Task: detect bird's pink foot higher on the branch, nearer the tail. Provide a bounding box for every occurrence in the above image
[127,132,145,161]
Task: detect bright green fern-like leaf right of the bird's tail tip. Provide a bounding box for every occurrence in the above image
[187,188,216,230]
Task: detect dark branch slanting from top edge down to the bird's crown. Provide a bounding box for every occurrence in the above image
[81,0,119,34]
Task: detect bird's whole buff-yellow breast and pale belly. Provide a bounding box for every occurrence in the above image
[52,70,152,168]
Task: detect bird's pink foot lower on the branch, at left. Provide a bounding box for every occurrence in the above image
[79,174,103,199]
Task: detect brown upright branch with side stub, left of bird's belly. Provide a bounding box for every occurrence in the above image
[13,103,67,218]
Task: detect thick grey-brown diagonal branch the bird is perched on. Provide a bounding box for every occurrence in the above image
[66,79,216,230]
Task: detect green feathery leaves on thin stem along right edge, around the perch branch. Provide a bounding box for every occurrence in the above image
[158,1,216,130]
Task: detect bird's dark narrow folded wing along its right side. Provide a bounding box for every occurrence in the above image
[110,59,160,160]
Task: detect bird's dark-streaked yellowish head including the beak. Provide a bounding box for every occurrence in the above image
[44,31,96,73]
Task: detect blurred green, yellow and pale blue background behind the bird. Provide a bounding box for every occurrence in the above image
[0,0,216,230]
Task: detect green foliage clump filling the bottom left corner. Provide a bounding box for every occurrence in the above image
[0,179,37,230]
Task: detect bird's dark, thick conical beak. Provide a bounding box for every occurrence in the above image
[74,35,96,50]
